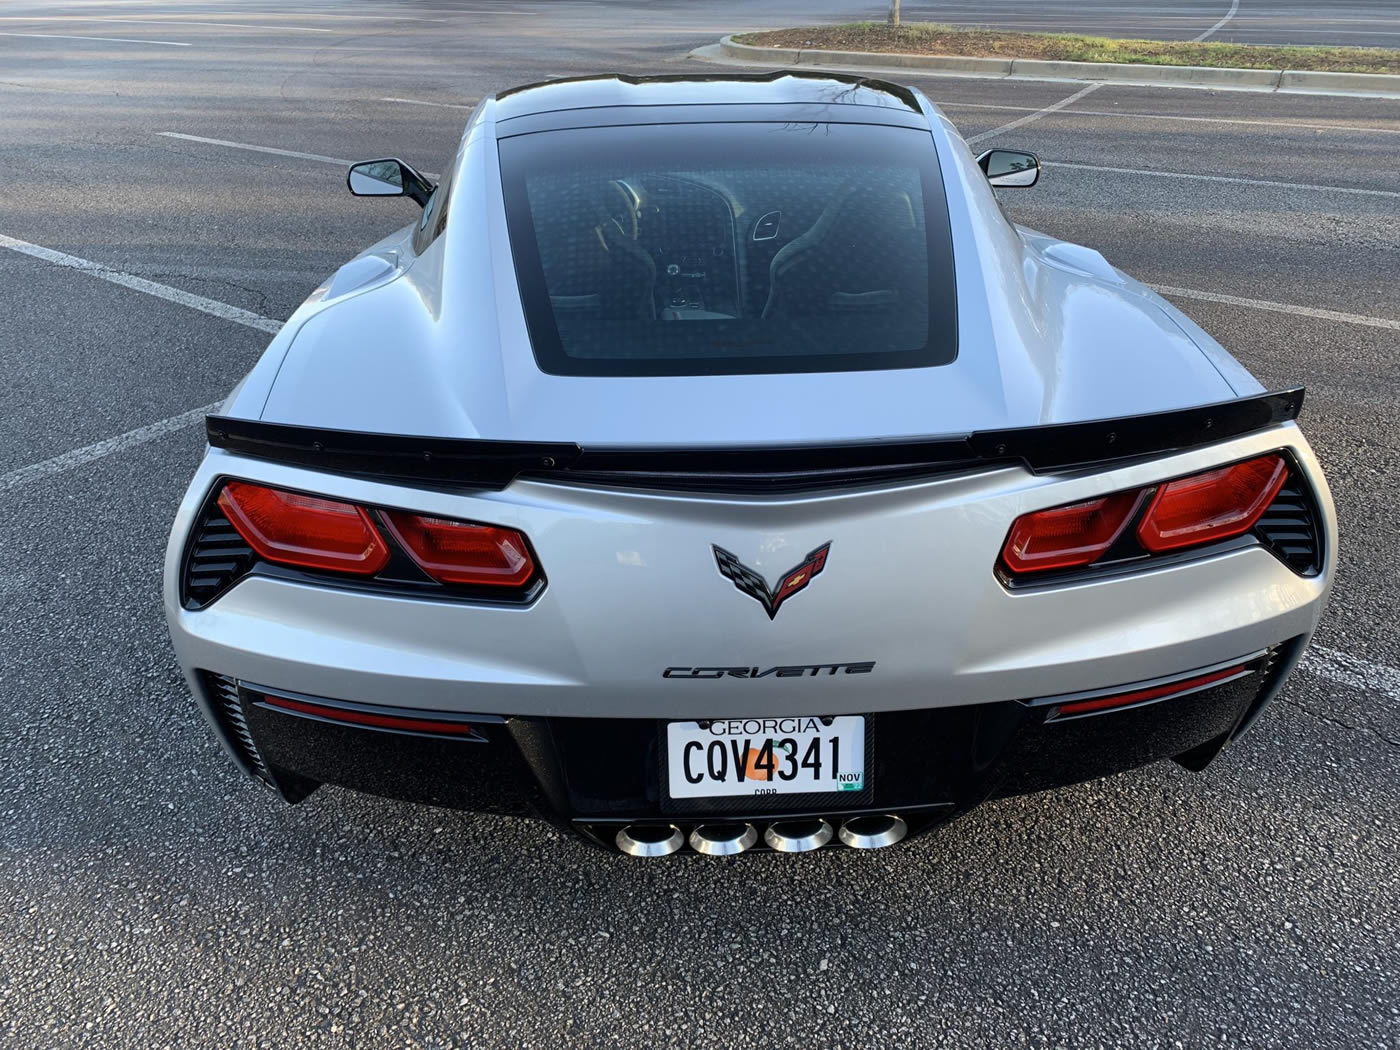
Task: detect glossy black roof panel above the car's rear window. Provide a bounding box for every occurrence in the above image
[496,70,923,120]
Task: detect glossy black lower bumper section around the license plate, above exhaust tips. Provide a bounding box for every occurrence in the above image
[195,638,1303,848]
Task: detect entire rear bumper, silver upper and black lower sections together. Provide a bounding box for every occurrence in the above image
[165,424,1336,843]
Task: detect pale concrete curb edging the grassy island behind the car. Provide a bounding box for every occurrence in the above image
[711,36,1400,98]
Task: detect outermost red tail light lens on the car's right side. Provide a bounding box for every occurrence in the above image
[1137,455,1288,553]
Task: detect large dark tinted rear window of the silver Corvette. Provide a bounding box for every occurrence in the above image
[500,123,958,375]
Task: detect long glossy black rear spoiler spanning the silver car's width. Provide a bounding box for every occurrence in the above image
[206,386,1303,490]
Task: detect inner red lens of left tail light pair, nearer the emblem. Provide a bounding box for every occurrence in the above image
[384,511,535,587]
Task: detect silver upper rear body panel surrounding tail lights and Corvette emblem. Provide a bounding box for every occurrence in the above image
[165,424,1336,720]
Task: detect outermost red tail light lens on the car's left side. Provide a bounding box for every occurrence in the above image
[218,482,389,575]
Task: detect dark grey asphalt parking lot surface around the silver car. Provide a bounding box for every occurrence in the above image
[0,0,1400,1050]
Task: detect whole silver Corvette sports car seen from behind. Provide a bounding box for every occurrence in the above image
[165,73,1336,857]
